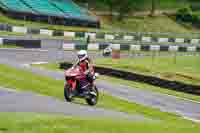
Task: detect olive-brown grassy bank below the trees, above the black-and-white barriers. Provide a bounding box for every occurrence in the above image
[102,16,200,33]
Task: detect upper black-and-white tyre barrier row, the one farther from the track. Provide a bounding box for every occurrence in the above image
[0,23,200,45]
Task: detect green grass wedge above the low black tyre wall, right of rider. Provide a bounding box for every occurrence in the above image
[95,56,200,85]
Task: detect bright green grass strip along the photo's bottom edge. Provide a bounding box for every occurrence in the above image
[0,113,200,133]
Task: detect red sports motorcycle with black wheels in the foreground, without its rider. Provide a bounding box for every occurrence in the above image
[64,62,99,106]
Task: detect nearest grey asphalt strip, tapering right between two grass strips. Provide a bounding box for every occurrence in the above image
[0,87,148,121]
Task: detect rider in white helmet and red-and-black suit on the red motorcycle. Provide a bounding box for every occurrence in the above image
[77,50,94,94]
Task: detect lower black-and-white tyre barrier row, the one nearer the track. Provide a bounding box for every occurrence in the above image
[0,37,200,53]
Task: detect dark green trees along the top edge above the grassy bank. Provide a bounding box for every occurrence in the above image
[74,0,197,20]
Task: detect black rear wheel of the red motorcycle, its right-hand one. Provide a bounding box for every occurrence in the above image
[86,86,99,106]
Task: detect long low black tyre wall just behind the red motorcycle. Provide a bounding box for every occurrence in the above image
[60,62,200,95]
